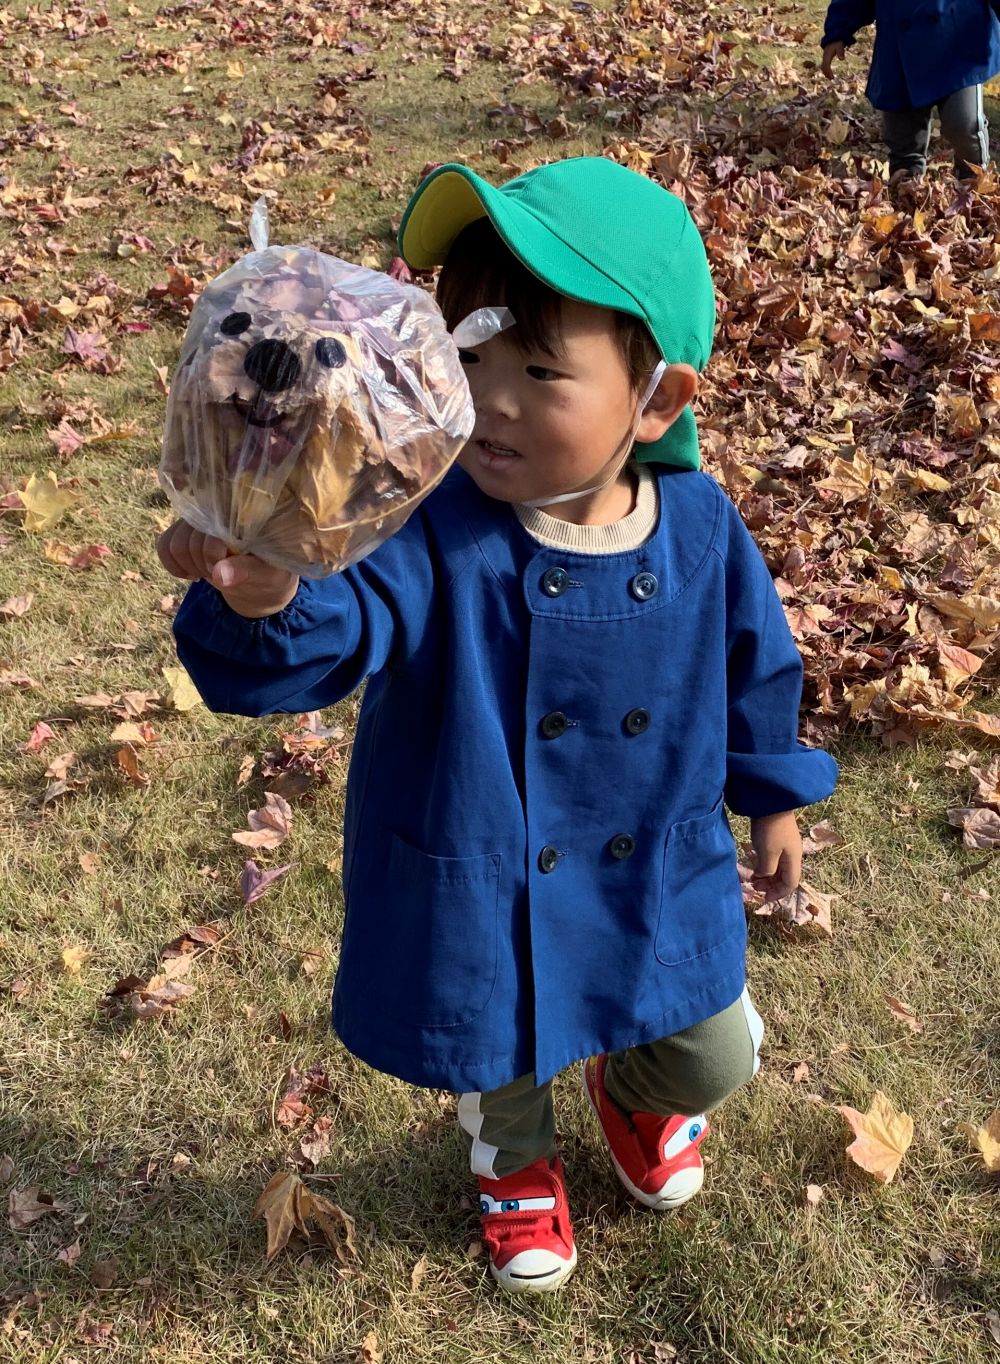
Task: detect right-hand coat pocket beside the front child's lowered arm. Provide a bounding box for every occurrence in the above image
[655,801,746,966]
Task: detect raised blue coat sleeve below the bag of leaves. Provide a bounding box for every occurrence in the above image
[173,517,434,715]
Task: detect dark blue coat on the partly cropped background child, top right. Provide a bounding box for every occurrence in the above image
[823,0,1000,109]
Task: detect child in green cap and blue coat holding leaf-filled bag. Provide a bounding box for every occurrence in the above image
[160,157,836,1292]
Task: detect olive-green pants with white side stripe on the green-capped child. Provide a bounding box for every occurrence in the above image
[458,990,764,1180]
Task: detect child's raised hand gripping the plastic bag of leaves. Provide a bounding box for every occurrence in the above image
[157,521,299,619]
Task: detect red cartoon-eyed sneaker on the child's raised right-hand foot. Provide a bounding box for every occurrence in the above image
[583,1056,708,1213]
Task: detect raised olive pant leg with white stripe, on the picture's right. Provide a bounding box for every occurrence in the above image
[604,990,764,1117]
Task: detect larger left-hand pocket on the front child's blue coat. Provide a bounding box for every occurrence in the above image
[354,833,501,1027]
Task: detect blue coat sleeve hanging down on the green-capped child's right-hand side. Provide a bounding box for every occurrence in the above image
[724,499,836,817]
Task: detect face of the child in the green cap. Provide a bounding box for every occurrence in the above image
[458,299,638,506]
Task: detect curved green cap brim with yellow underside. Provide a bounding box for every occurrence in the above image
[400,164,645,321]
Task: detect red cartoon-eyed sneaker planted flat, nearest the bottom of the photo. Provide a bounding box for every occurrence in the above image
[479,1155,576,1293]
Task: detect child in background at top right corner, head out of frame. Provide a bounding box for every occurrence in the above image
[821,0,1000,180]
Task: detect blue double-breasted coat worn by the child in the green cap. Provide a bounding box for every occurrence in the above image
[175,468,836,1090]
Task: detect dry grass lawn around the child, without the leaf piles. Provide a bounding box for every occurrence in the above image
[0,0,1000,1364]
